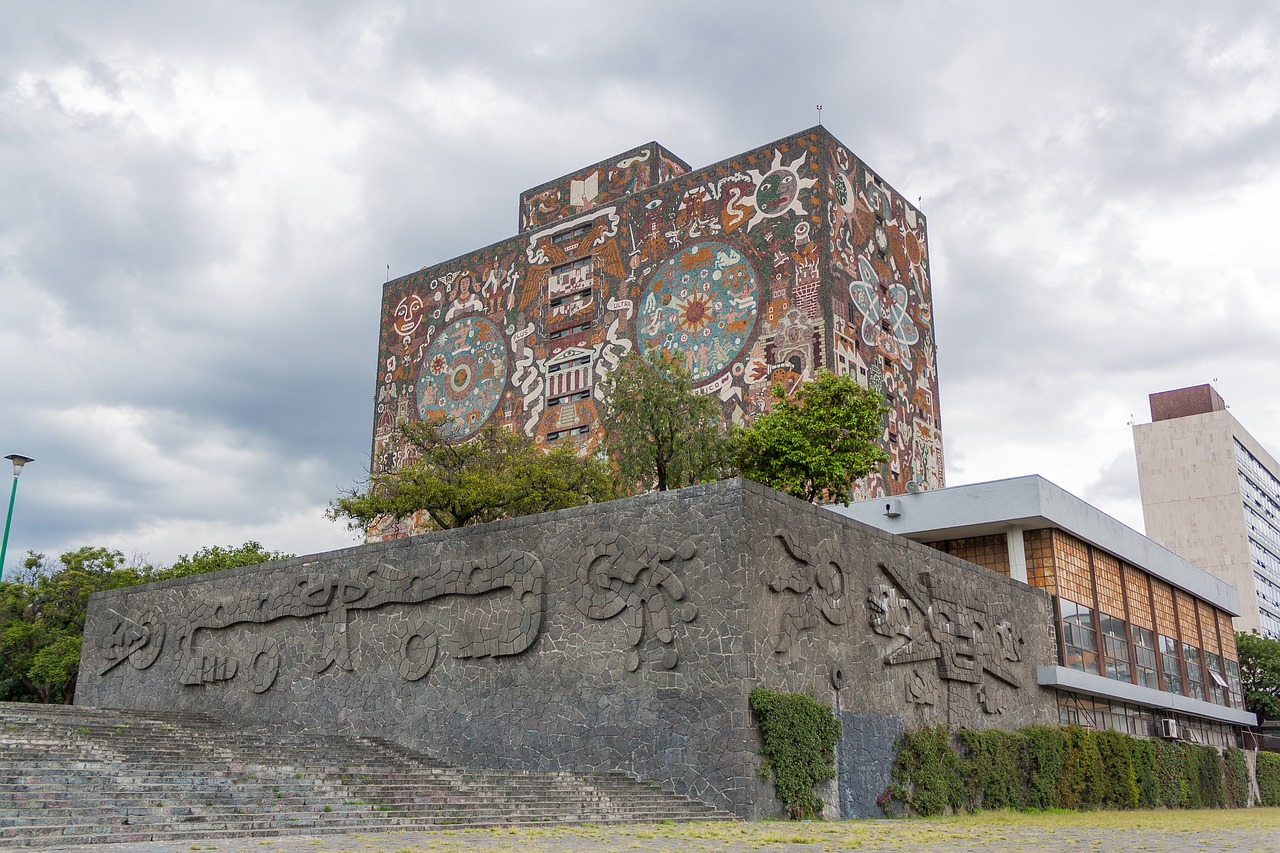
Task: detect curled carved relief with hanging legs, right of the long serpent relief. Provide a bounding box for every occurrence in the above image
[577,533,698,672]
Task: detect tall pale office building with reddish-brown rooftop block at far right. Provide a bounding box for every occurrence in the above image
[1133,386,1280,638]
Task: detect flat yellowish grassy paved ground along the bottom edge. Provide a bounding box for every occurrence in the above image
[14,809,1280,853]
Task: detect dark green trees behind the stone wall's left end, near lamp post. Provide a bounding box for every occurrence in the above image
[0,542,289,703]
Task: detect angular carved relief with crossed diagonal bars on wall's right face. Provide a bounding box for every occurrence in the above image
[867,562,1023,724]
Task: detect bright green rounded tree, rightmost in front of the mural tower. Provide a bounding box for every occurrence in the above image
[733,370,888,502]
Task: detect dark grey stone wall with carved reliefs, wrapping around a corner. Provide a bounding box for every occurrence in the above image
[77,480,1056,817]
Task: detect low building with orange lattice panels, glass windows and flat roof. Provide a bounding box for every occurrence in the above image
[828,476,1256,747]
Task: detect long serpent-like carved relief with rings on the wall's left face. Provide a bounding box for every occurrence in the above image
[163,551,545,693]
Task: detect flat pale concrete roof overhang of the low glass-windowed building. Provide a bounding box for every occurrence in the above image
[826,474,1240,614]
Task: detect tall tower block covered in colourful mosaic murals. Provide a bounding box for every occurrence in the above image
[370,127,943,539]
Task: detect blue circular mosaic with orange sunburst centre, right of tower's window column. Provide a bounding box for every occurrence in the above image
[636,242,759,383]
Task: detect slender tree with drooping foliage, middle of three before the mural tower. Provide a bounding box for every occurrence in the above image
[600,351,732,494]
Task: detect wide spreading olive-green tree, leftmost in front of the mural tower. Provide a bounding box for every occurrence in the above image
[328,421,614,530]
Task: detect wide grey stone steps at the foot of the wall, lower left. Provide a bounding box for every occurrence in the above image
[0,703,732,848]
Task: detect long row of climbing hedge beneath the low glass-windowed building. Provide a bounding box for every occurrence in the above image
[878,726,1254,816]
